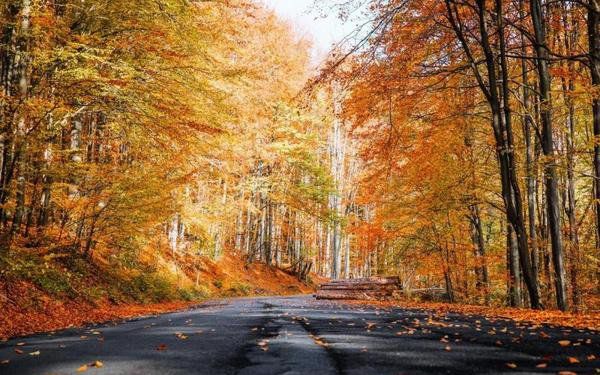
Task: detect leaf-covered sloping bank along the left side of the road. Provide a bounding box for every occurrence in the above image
[0,254,318,340]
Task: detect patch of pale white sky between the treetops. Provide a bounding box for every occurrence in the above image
[263,0,353,63]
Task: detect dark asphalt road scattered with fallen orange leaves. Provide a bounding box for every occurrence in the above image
[0,296,600,375]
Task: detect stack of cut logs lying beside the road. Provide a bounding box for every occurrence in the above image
[315,276,402,300]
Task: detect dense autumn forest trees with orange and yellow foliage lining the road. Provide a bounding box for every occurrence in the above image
[0,0,600,338]
